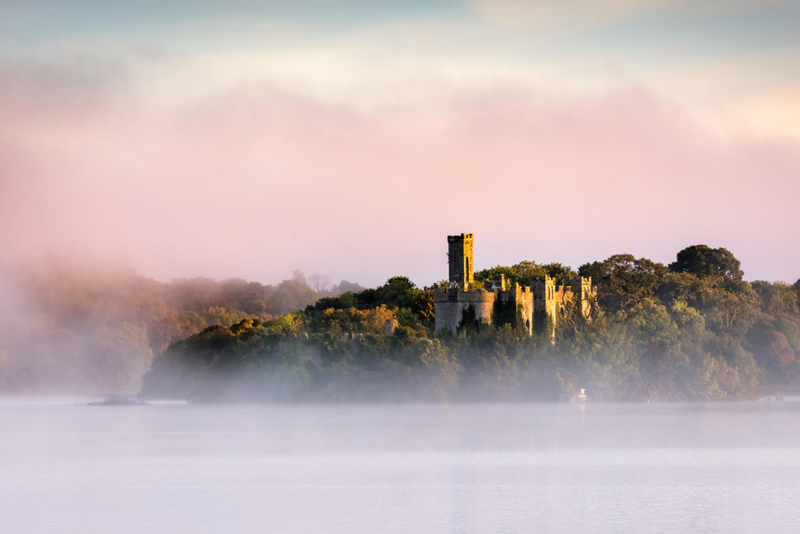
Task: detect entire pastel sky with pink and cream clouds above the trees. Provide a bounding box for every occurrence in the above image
[0,0,800,286]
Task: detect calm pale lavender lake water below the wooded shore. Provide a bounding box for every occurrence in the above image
[0,401,800,534]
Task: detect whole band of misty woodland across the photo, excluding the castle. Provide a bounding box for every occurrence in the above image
[0,245,800,401]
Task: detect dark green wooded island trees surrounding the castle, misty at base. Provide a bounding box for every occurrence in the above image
[142,245,800,402]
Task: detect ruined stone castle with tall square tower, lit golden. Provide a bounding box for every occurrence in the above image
[434,234,595,336]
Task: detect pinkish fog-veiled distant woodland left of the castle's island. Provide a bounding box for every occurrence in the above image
[0,256,363,395]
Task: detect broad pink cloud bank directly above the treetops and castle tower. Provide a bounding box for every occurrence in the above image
[0,77,800,284]
